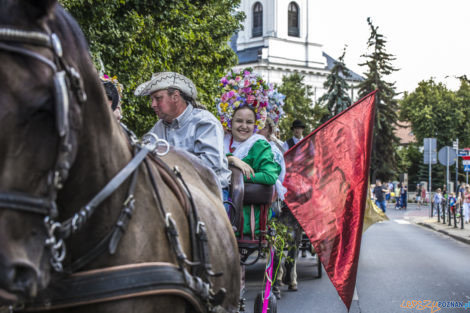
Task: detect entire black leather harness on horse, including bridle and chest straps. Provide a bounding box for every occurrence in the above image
[0,27,226,312]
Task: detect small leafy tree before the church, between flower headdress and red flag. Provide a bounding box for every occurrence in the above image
[278,73,328,140]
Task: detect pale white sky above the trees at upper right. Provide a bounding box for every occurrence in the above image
[309,0,470,92]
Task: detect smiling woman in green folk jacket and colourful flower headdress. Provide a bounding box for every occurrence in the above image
[217,69,281,235]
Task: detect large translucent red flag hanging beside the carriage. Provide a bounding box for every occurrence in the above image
[284,91,375,310]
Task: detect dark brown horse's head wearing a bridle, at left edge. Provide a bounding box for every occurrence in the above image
[0,0,98,305]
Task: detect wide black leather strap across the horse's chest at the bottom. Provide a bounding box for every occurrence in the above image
[19,262,209,312]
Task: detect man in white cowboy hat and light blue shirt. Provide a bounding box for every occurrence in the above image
[134,72,231,188]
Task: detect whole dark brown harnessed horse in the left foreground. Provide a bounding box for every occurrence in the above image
[0,0,240,313]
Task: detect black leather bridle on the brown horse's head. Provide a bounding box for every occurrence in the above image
[0,27,86,271]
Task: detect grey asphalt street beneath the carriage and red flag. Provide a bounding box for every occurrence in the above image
[242,204,470,313]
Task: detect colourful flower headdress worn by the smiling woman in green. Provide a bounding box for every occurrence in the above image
[217,68,270,133]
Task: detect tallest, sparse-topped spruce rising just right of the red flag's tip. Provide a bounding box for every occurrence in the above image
[359,18,398,180]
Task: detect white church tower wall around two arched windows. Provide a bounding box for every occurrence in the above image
[237,0,357,101]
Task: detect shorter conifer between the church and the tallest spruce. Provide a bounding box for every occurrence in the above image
[318,48,352,123]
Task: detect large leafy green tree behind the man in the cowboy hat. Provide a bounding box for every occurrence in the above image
[60,0,244,135]
